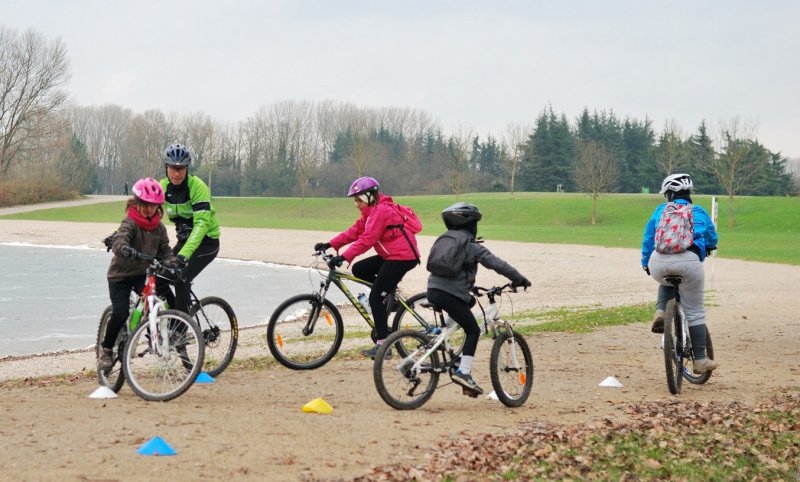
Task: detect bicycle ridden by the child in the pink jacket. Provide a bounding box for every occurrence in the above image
[267,251,465,370]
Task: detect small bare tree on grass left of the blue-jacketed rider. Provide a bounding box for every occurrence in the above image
[575,141,620,225]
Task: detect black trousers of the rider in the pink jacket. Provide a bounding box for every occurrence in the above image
[352,255,418,340]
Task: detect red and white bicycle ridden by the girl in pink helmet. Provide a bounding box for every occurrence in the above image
[95,253,205,401]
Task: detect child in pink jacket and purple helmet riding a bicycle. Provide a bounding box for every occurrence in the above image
[314,176,422,359]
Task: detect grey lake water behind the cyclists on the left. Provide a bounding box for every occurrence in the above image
[0,243,344,357]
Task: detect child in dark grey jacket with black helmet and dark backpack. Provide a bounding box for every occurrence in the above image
[426,202,531,394]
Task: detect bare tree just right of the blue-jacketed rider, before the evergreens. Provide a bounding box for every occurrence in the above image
[704,116,769,228]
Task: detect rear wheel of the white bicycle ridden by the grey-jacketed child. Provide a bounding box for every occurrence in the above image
[372,330,443,410]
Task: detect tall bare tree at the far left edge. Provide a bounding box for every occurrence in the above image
[0,26,70,178]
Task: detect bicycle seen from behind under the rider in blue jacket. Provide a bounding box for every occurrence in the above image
[662,275,714,395]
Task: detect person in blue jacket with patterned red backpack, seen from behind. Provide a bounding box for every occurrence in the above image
[641,174,718,374]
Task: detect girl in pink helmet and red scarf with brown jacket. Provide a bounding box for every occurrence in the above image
[97,178,175,370]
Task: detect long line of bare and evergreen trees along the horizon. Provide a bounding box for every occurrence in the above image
[0,27,797,220]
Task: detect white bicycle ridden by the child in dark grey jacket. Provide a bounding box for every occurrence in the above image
[373,284,533,410]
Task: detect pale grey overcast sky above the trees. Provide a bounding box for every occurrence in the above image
[0,0,800,157]
